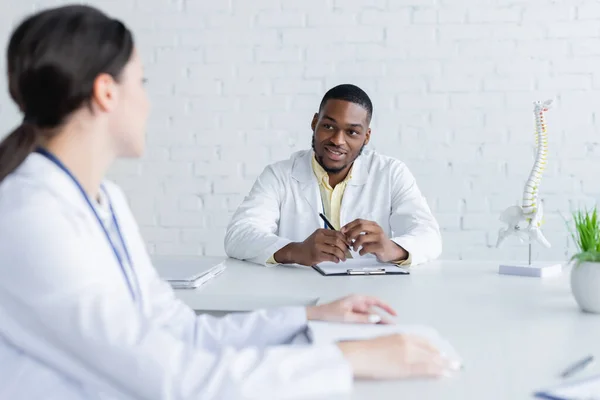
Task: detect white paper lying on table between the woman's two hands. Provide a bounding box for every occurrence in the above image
[307,321,462,365]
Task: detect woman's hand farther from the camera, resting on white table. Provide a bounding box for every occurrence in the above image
[306,295,396,324]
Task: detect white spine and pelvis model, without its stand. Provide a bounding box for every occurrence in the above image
[496,100,552,247]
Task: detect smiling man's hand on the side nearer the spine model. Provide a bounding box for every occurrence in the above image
[341,219,408,262]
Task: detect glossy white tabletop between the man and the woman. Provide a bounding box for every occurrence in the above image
[155,258,600,400]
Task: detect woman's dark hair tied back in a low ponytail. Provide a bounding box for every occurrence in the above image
[0,5,133,182]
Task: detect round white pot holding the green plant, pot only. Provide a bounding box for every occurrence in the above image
[571,262,600,313]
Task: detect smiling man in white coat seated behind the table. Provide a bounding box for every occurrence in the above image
[225,84,442,266]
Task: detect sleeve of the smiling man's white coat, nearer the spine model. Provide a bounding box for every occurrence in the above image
[390,161,442,265]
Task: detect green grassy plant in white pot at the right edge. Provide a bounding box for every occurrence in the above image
[571,207,600,313]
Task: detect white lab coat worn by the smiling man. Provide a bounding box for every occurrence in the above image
[225,150,442,265]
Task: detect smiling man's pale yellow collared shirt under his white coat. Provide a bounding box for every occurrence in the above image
[267,156,411,265]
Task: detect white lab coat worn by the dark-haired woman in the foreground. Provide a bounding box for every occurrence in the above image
[0,154,352,400]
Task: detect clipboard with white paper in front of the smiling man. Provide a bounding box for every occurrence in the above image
[313,256,410,276]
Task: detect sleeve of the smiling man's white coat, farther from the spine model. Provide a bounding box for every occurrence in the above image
[225,166,291,265]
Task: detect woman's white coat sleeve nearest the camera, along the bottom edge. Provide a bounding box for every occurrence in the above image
[0,209,351,400]
